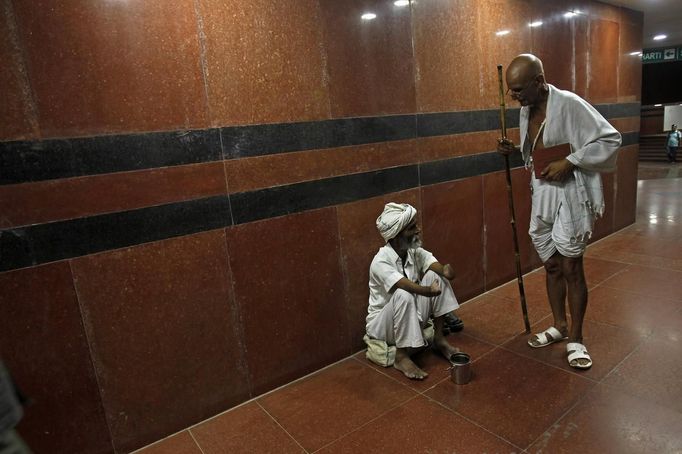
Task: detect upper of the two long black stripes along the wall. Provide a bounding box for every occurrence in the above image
[0,103,639,184]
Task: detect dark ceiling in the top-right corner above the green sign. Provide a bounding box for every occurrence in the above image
[602,0,682,49]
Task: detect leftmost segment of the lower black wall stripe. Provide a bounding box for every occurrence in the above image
[0,196,232,271]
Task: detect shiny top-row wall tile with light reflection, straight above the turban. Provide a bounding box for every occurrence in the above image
[320,0,416,118]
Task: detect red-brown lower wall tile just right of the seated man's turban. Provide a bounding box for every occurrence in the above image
[422,177,485,302]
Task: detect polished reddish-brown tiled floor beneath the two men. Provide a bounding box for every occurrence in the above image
[134,166,682,454]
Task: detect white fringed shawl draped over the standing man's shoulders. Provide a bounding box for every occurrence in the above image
[519,84,621,240]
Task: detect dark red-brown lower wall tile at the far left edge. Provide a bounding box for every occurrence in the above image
[0,262,114,453]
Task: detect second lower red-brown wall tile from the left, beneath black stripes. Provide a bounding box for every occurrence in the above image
[72,230,249,452]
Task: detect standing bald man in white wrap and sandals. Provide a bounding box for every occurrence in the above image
[497,54,621,369]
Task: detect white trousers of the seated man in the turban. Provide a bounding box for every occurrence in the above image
[367,271,459,348]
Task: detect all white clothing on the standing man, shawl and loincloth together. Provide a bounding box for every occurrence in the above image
[519,84,621,261]
